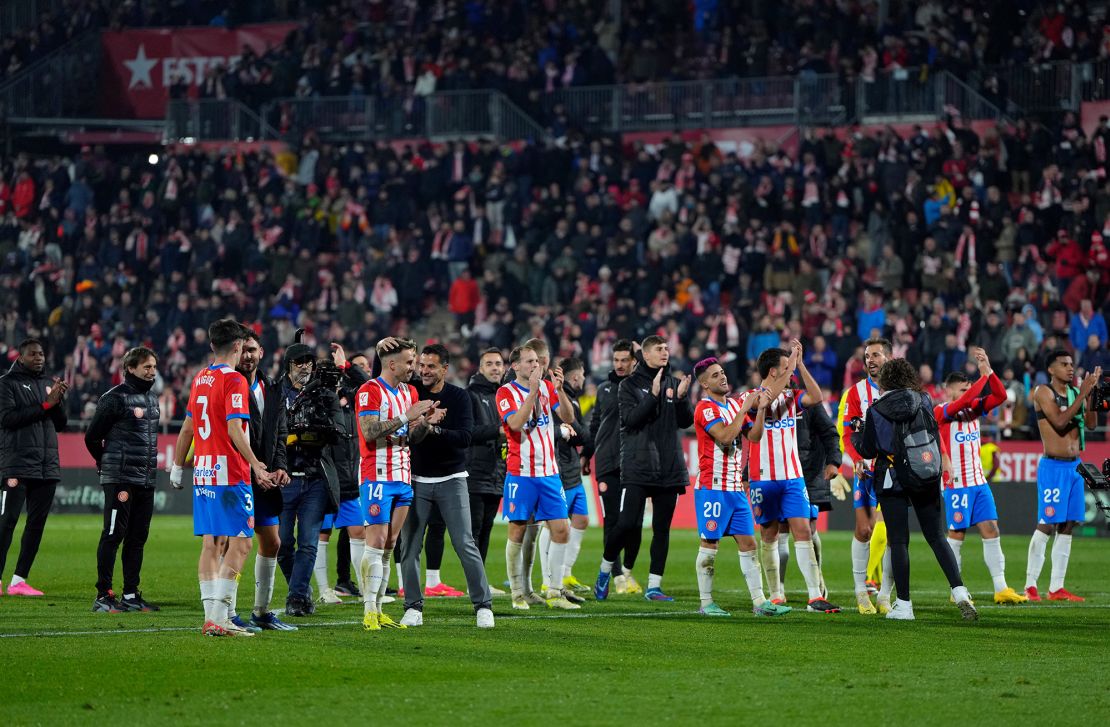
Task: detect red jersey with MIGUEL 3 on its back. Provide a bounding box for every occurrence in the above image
[185,364,251,487]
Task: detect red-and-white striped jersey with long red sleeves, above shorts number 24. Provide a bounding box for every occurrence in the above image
[932,373,1006,489]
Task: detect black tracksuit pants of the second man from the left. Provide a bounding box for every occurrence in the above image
[97,485,154,596]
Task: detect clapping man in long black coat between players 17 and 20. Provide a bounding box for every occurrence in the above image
[594,335,694,600]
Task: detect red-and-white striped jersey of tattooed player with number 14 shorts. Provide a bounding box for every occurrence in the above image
[355,377,420,484]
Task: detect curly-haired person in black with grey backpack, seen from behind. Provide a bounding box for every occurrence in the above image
[851,359,979,620]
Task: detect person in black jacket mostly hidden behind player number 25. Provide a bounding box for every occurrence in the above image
[773,403,842,598]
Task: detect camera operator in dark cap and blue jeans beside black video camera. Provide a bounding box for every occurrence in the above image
[278,342,343,617]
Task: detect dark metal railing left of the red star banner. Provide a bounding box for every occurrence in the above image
[0,31,101,117]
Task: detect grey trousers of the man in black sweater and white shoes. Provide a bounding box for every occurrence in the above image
[401,477,493,610]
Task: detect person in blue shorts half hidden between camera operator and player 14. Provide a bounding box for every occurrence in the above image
[314,343,370,604]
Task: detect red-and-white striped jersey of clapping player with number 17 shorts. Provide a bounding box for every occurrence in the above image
[497,380,558,477]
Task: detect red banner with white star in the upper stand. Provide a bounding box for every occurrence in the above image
[100,23,296,119]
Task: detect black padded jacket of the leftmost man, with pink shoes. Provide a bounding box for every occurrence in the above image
[0,361,65,482]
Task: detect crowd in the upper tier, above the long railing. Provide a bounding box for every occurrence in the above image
[0,0,1110,109]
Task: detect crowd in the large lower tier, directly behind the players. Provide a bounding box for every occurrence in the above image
[0,103,1110,432]
